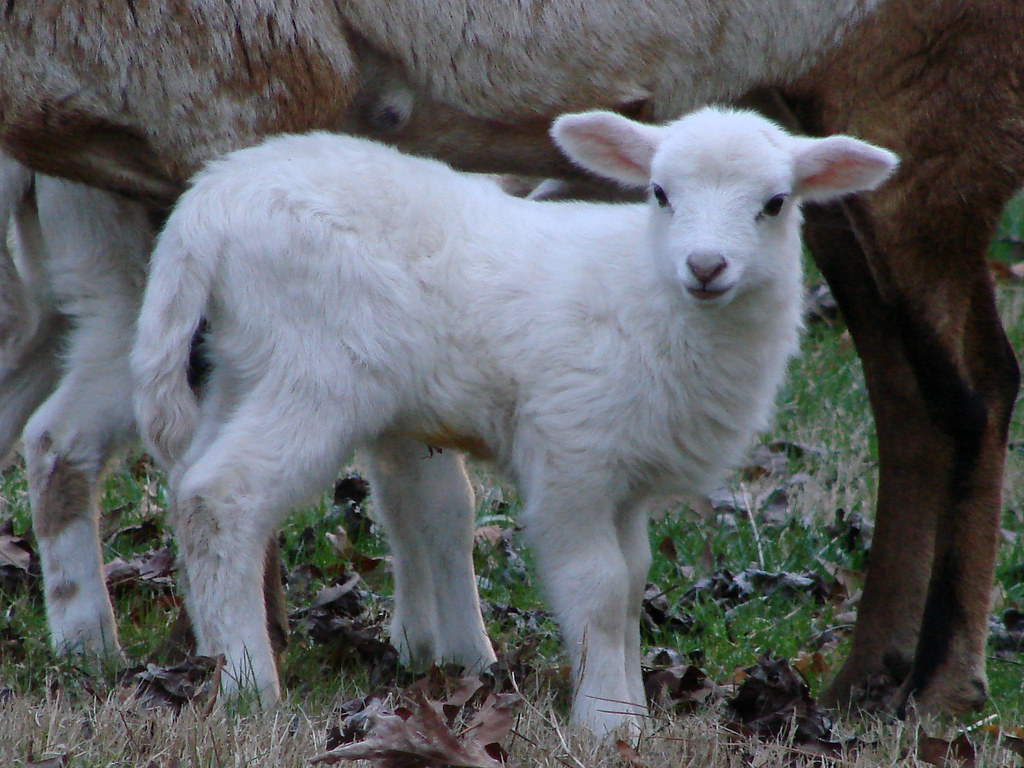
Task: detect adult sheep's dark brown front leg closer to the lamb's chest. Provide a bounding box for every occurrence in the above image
[805,199,942,705]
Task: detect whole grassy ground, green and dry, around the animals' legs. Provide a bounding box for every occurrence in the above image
[0,195,1024,768]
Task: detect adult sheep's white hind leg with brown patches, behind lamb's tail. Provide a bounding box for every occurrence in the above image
[25,179,152,655]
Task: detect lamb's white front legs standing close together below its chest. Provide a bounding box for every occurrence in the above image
[524,470,647,735]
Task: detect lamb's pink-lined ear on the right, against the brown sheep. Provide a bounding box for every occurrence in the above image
[795,136,899,203]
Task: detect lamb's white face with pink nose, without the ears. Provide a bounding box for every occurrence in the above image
[648,121,800,307]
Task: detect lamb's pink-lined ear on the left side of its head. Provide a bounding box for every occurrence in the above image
[551,112,662,186]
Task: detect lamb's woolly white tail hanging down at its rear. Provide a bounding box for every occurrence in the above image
[131,206,216,468]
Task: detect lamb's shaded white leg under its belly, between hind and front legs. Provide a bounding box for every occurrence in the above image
[369,438,495,671]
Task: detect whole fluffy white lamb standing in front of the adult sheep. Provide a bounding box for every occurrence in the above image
[132,109,896,733]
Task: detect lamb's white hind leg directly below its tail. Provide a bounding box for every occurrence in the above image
[170,399,348,706]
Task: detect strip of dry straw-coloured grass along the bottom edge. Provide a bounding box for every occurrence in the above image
[0,679,1013,768]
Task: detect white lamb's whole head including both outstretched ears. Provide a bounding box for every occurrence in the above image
[551,108,897,306]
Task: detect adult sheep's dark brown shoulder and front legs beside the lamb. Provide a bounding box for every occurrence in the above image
[790,0,1024,713]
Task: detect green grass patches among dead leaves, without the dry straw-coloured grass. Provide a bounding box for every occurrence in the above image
[0,200,1024,766]
